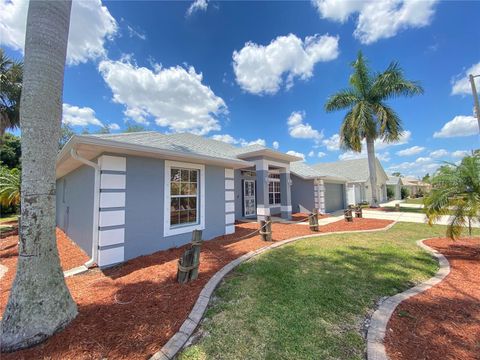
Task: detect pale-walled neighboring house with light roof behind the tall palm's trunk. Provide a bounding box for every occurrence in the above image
[312,158,388,205]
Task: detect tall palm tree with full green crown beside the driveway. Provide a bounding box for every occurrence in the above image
[325,51,423,207]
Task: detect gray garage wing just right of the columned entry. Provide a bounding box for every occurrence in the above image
[290,161,347,213]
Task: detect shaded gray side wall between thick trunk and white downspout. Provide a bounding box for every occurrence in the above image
[56,165,95,255]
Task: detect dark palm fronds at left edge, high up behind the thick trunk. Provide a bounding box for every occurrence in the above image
[0,49,23,141]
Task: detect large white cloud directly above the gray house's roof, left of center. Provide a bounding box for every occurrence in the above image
[98,58,228,135]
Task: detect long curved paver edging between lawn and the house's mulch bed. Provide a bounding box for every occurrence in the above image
[150,221,396,360]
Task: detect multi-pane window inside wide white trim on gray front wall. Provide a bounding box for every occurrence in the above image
[170,167,199,226]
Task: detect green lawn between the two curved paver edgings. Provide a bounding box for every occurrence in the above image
[179,223,478,360]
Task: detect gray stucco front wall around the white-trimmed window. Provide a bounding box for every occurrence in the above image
[125,156,228,260]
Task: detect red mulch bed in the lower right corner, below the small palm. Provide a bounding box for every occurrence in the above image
[385,238,480,360]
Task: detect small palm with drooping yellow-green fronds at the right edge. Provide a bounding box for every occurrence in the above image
[424,155,480,239]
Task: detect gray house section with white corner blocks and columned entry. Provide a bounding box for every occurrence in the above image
[56,132,300,267]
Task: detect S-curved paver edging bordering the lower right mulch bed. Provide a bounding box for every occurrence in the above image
[367,239,450,360]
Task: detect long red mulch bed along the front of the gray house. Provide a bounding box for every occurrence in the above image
[0,219,391,360]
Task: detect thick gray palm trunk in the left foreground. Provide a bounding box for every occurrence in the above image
[1,0,77,351]
